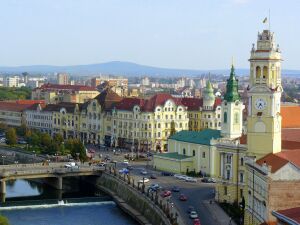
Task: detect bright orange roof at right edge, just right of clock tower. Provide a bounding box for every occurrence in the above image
[281,105,300,128]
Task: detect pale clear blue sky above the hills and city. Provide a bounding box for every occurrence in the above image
[0,0,300,69]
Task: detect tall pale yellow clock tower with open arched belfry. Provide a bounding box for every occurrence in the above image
[247,30,282,158]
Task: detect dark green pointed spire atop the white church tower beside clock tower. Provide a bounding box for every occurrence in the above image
[224,65,241,102]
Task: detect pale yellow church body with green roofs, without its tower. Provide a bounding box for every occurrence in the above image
[153,129,221,177]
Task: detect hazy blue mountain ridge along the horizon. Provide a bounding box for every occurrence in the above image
[0,61,300,77]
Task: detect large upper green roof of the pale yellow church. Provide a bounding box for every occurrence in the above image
[169,129,221,145]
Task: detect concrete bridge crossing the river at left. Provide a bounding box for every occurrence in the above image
[0,163,105,202]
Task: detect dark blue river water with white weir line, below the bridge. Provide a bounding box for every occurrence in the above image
[0,180,137,225]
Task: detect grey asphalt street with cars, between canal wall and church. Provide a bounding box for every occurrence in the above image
[87,146,225,225]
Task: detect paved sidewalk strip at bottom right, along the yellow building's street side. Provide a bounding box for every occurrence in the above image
[202,200,236,225]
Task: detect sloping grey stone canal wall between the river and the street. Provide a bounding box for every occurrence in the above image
[94,172,178,225]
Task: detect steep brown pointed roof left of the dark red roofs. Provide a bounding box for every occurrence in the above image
[95,88,123,110]
